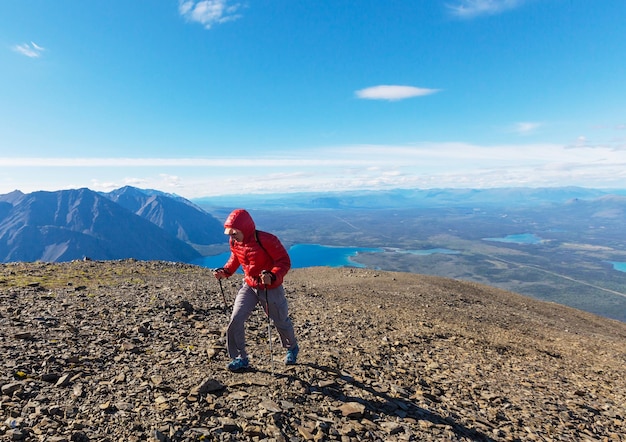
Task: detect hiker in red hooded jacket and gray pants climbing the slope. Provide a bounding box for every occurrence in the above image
[213,209,299,371]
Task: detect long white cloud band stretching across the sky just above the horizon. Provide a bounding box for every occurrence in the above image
[0,142,626,198]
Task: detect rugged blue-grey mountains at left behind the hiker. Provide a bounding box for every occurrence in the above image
[0,187,224,262]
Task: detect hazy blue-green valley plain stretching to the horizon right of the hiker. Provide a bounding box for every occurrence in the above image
[194,187,626,321]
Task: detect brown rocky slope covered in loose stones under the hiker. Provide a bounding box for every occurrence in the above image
[0,260,626,442]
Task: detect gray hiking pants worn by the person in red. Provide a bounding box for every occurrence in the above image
[226,282,297,359]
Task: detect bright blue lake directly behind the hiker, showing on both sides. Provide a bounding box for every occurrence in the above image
[192,244,459,268]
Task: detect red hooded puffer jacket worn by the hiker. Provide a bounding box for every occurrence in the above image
[224,209,291,288]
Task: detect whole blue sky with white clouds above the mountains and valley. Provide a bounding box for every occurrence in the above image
[0,0,626,198]
